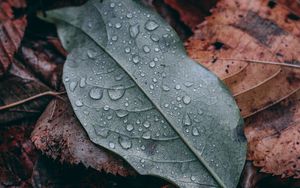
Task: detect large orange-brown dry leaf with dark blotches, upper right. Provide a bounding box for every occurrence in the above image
[187,0,300,117]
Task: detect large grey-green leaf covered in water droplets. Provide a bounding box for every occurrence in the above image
[42,0,246,188]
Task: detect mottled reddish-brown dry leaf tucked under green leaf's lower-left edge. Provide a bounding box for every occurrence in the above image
[32,99,135,176]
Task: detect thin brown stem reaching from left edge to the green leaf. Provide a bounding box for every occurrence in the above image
[0,91,66,111]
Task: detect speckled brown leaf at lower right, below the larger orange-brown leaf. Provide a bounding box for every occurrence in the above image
[245,92,300,178]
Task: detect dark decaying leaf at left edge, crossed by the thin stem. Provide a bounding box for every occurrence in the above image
[0,60,50,125]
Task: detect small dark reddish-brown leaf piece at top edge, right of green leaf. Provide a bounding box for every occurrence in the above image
[164,0,217,29]
